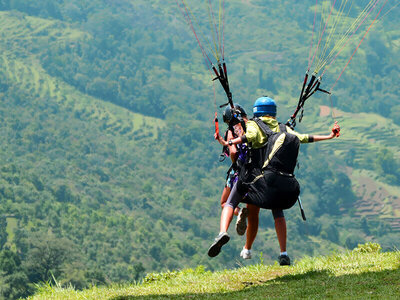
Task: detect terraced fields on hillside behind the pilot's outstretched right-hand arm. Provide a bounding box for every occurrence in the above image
[306,106,400,231]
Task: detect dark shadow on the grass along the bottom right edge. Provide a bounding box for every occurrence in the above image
[112,268,400,300]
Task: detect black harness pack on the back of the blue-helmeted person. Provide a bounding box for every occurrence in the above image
[234,118,300,213]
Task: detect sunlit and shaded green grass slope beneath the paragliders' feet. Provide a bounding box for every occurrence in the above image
[29,243,400,300]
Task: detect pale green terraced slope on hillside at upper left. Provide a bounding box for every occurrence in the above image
[0,12,164,139]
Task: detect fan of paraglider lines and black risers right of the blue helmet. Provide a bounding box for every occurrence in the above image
[286,0,394,128]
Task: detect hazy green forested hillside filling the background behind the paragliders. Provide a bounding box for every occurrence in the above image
[0,0,400,299]
